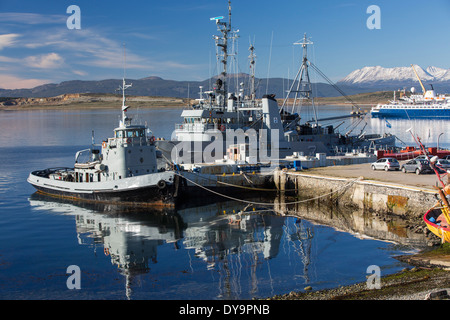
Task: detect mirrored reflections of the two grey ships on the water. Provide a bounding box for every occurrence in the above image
[30,193,298,299]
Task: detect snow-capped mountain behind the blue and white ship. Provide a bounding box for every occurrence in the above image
[339,65,450,85]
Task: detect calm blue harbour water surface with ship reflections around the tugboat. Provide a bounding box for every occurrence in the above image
[0,107,450,299]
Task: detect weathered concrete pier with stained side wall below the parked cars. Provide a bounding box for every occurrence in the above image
[274,163,437,219]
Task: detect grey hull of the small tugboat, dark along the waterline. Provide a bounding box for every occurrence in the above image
[28,171,177,207]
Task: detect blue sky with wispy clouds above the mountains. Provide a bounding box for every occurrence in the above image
[0,0,450,88]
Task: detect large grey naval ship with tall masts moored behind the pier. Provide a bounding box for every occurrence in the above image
[157,1,395,164]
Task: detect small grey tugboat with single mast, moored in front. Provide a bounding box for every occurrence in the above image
[27,79,179,206]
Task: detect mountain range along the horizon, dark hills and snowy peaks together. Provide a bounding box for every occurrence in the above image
[0,65,450,98]
